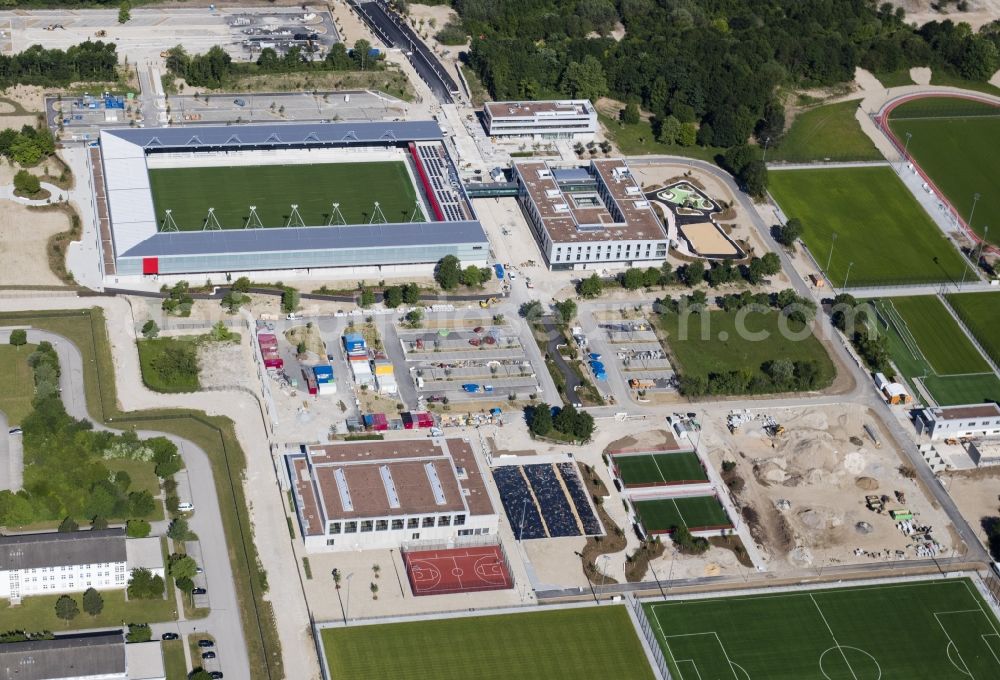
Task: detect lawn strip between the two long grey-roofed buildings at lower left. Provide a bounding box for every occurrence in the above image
[0,590,177,633]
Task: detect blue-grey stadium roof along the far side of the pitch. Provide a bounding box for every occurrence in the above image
[101,120,441,151]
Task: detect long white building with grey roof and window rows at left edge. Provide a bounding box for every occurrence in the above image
[0,529,129,603]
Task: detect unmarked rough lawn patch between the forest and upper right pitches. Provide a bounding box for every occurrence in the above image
[767,99,883,162]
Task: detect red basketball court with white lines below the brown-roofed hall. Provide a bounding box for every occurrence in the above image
[403,545,514,595]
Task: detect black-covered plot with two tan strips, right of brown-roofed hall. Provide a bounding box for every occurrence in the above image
[493,462,604,540]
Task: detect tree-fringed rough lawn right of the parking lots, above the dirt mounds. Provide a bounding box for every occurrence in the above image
[660,310,836,388]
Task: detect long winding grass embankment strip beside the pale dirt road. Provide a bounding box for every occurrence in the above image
[0,308,284,678]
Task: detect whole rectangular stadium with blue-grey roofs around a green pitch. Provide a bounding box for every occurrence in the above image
[88,121,489,282]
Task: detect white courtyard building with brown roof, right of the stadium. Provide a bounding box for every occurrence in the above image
[514,159,669,269]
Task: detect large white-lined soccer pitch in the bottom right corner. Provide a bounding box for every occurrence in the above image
[643,579,1000,680]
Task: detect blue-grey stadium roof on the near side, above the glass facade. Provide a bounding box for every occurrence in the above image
[121,222,486,257]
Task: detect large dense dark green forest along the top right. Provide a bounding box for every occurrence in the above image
[453,0,1000,147]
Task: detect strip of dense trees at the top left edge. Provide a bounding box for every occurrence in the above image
[0,40,118,89]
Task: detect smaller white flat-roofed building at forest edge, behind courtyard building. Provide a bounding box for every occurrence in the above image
[483,99,597,139]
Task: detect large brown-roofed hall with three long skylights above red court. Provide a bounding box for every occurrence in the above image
[285,438,500,552]
